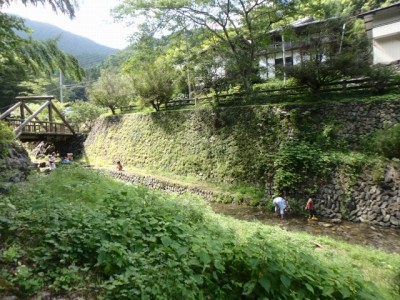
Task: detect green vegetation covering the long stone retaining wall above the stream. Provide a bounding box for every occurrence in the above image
[85,99,399,204]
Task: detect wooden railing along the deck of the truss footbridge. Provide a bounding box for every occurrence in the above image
[5,118,78,135]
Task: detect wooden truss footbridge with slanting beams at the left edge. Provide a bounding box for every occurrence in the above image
[0,96,77,141]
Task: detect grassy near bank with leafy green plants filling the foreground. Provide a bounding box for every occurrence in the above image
[0,166,400,299]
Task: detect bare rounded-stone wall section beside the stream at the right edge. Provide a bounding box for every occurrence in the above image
[316,162,400,228]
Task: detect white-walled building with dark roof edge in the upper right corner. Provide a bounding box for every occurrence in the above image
[358,2,400,64]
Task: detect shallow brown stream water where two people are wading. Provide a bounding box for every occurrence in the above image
[210,203,400,253]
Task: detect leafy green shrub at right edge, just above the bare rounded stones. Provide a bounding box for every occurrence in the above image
[362,123,400,158]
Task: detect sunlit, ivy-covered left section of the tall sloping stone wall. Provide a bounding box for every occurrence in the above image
[85,107,286,182]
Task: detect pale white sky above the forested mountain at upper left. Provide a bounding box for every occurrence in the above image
[2,0,133,49]
